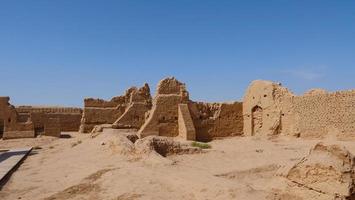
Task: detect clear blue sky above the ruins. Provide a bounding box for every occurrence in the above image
[0,0,355,106]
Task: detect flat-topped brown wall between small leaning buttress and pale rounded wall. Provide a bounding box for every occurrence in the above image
[189,102,243,141]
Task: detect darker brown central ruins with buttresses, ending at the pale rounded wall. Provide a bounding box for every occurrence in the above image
[80,77,243,141]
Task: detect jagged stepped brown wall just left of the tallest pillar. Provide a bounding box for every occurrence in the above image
[80,84,151,133]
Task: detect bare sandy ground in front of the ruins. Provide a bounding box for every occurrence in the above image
[0,130,350,200]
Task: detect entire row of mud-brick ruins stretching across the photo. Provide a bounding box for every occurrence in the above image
[0,77,355,141]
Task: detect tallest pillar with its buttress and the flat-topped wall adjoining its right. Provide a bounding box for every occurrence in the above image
[139,77,243,141]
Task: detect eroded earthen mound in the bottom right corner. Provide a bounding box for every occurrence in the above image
[287,143,355,199]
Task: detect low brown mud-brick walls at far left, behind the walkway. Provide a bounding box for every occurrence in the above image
[0,97,82,139]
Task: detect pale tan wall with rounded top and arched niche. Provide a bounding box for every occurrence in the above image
[243,81,355,138]
